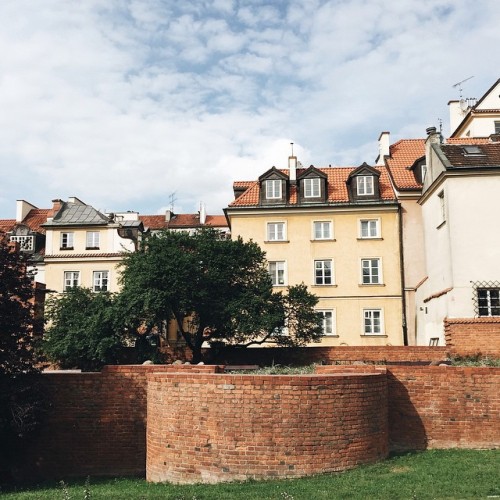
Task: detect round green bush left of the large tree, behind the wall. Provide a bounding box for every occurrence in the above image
[43,287,122,371]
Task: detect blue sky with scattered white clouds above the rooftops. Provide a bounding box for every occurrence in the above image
[0,0,500,219]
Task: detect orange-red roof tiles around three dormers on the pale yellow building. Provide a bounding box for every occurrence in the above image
[229,167,396,207]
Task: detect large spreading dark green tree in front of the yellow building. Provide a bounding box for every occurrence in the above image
[118,230,321,363]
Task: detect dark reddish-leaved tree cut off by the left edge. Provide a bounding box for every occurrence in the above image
[0,236,43,478]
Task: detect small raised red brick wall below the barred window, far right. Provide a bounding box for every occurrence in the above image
[444,317,500,358]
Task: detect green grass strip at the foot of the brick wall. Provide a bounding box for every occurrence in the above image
[0,450,500,500]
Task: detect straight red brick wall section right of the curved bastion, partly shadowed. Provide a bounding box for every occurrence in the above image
[387,366,500,450]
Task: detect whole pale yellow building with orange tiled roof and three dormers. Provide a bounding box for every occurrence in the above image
[226,157,404,345]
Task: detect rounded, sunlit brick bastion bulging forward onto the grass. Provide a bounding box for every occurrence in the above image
[146,372,388,483]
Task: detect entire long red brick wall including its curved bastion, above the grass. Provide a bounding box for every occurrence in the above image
[17,365,500,481]
